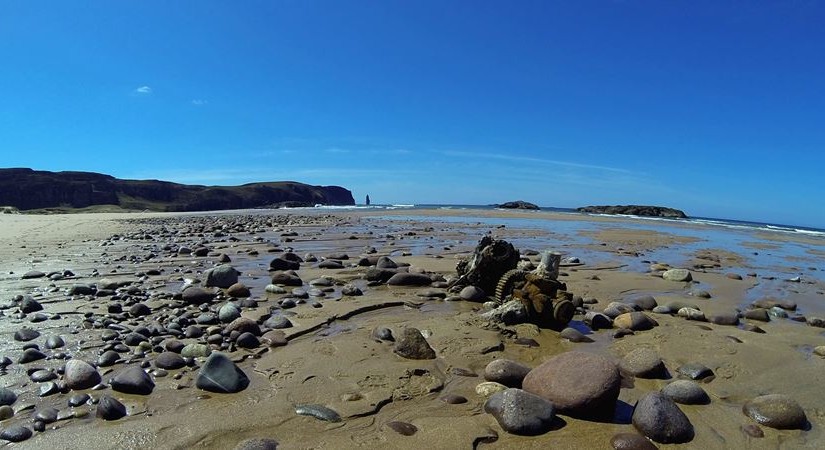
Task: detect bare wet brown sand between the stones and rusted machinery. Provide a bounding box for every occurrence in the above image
[0,210,825,449]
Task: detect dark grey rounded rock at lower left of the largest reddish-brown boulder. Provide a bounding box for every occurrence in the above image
[484,388,556,436]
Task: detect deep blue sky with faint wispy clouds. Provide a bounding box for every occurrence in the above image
[0,0,825,228]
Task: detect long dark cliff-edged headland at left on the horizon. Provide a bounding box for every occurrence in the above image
[0,168,355,211]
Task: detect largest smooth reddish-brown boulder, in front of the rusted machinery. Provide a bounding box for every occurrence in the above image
[523,352,621,418]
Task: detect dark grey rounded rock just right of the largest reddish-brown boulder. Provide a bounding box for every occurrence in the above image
[632,392,694,444]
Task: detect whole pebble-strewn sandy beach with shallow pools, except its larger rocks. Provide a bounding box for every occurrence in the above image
[0,209,825,449]
